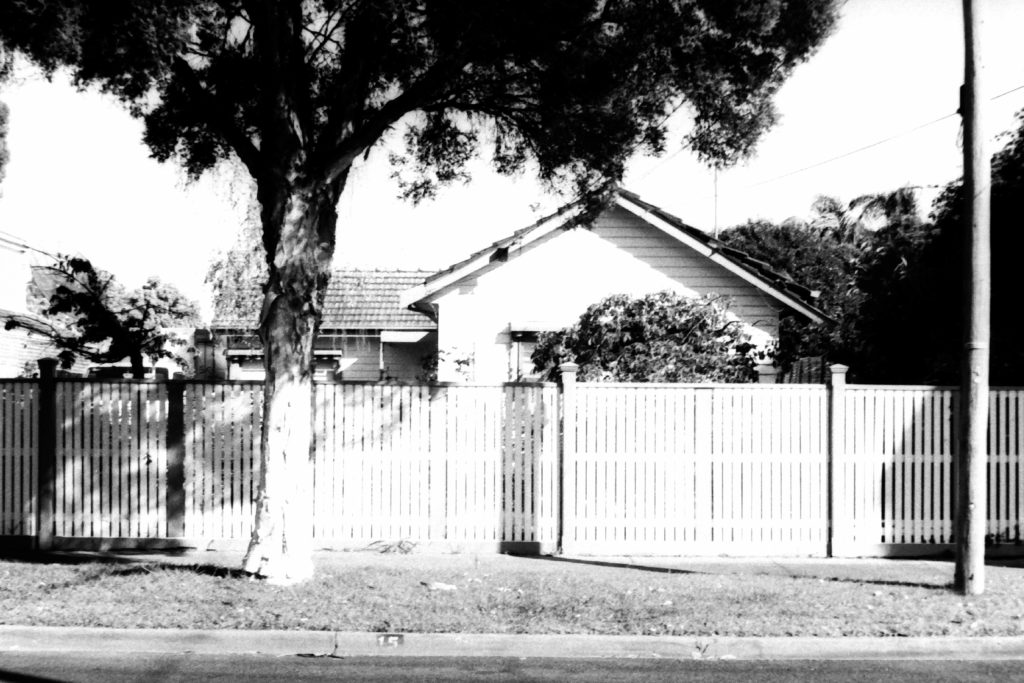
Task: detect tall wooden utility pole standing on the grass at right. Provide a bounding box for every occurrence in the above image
[953,0,992,595]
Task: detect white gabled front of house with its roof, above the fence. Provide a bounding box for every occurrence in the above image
[401,189,827,383]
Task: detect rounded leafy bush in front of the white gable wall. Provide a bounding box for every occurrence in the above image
[532,292,757,382]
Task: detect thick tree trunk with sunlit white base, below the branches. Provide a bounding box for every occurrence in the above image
[244,179,343,584]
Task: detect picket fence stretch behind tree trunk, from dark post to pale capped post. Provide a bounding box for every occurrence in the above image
[184,384,558,548]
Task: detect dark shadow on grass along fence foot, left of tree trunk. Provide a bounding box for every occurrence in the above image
[0,548,252,583]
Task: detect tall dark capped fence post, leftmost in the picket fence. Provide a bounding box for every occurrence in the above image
[36,358,57,550]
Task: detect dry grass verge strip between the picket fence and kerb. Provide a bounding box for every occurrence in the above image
[0,553,1024,636]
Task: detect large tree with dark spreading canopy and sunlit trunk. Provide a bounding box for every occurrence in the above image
[0,0,837,582]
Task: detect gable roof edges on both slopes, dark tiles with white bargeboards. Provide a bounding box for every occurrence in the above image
[401,188,829,322]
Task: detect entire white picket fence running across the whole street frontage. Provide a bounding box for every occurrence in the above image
[0,380,1024,555]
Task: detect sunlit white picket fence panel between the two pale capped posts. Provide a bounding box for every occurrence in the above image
[563,384,828,554]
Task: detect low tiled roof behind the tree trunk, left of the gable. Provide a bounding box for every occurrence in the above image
[212,269,437,330]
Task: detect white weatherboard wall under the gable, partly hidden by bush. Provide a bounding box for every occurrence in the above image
[434,208,778,382]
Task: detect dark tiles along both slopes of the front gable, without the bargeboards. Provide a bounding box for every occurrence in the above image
[411,188,828,319]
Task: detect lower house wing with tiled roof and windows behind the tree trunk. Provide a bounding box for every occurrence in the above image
[195,269,437,382]
